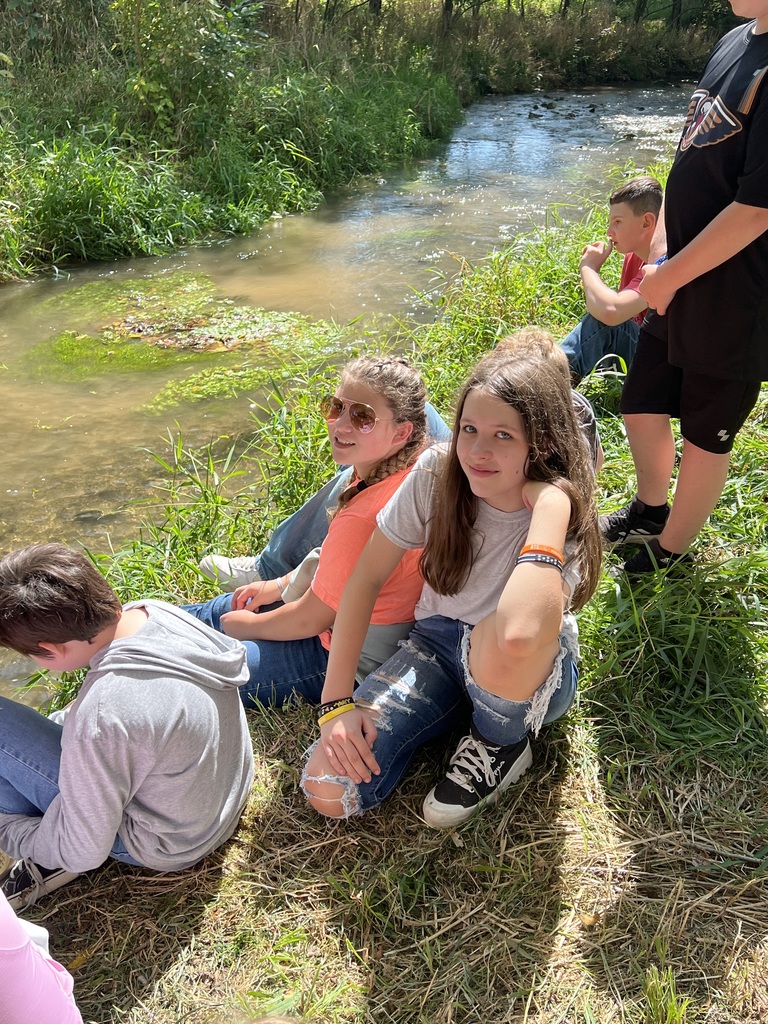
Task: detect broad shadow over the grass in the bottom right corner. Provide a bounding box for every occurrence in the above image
[579,553,768,1022]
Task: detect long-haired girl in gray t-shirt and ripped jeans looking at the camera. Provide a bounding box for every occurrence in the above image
[303,346,601,827]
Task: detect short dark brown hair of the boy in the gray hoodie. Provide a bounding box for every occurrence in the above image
[0,544,122,657]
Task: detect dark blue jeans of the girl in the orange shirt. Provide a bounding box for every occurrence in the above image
[182,594,328,708]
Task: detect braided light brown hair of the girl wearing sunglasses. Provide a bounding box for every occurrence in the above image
[329,355,427,519]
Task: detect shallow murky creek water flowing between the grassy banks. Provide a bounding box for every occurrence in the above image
[0,86,687,688]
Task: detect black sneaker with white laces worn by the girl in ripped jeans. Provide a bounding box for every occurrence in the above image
[423,727,534,828]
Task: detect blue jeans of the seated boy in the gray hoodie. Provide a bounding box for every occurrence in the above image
[0,696,141,866]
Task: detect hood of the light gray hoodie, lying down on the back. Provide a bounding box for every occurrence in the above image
[90,599,249,690]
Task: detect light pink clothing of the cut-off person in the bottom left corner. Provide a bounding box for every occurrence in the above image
[0,892,83,1024]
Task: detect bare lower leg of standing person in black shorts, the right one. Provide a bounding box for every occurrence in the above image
[658,441,730,551]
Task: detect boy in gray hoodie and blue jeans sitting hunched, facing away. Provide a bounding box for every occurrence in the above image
[0,544,253,909]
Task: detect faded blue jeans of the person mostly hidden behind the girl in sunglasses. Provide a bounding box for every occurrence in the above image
[256,402,451,580]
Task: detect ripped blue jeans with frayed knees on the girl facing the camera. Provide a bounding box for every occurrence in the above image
[302,615,579,817]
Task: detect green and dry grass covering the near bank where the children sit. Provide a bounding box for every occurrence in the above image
[16,186,768,1024]
